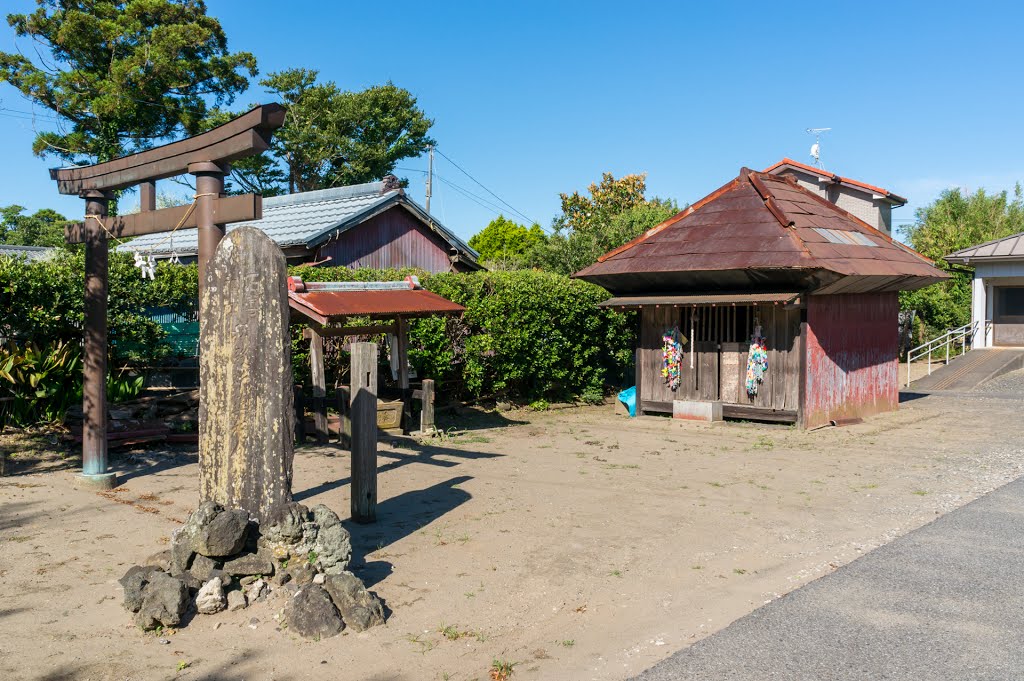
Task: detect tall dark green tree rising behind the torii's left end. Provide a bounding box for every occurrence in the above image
[0,0,256,163]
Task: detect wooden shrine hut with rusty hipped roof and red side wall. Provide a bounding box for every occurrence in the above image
[575,168,947,428]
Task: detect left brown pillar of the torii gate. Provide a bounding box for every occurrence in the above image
[79,189,117,490]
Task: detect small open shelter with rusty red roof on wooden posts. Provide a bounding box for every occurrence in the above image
[288,276,466,441]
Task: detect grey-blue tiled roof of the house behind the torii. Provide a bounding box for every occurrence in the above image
[117,182,479,260]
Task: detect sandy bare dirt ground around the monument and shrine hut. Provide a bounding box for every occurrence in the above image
[0,373,1024,681]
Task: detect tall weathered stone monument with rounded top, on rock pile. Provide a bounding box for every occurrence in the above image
[199,227,295,523]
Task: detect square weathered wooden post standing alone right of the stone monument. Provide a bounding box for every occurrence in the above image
[351,343,377,522]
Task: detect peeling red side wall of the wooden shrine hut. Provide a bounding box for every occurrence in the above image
[804,293,899,428]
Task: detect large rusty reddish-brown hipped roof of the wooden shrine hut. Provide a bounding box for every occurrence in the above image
[575,168,948,293]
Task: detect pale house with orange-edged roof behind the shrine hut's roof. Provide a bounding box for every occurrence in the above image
[765,159,906,235]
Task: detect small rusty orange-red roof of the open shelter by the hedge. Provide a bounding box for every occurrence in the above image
[288,289,466,324]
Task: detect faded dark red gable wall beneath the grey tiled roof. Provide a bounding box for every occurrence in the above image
[316,206,464,272]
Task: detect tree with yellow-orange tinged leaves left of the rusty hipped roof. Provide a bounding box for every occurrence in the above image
[529,173,679,274]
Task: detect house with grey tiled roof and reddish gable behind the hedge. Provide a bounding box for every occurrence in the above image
[118,176,480,272]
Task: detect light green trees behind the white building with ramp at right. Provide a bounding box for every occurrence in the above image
[900,184,1024,333]
